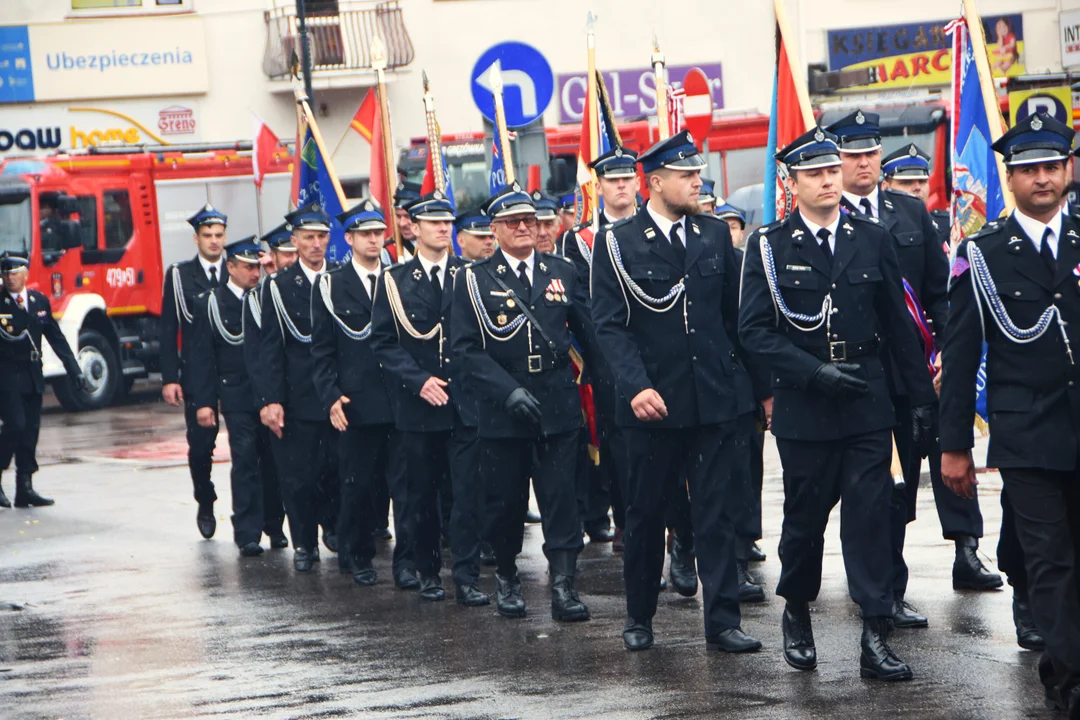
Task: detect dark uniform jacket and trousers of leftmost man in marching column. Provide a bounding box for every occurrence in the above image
[159,256,229,504]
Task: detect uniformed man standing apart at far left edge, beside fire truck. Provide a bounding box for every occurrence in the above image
[0,252,89,507]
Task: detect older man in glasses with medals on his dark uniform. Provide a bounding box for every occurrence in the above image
[451,184,592,622]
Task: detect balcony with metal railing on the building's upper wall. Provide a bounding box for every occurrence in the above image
[262,0,415,78]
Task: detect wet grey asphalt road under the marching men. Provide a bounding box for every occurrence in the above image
[0,382,1056,720]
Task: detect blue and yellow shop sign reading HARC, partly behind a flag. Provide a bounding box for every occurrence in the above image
[828,13,1024,90]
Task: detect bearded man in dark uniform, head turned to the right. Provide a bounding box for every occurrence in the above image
[592,131,768,652]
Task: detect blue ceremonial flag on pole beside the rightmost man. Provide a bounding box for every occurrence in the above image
[945,12,1007,433]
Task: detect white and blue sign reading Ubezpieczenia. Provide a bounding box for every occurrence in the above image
[0,17,208,103]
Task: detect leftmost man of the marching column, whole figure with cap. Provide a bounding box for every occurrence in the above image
[159,205,228,540]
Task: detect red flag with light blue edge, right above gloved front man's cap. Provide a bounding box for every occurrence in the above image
[762,0,814,223]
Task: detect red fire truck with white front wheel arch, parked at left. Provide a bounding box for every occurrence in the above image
[0,142,291,410]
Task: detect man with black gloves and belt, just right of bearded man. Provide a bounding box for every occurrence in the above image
[743,127,936,680]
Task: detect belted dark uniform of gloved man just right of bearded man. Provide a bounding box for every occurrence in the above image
[740,210,935,617]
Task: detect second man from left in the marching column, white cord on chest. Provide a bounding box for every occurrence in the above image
[188,235,272,557]
